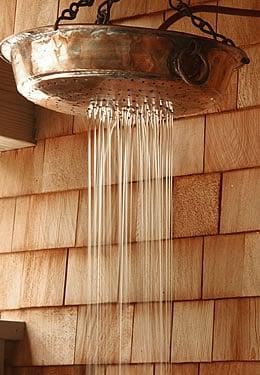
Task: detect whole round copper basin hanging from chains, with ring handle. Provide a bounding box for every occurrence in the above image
[0,25,248,117]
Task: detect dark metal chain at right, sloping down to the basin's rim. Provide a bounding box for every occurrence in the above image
[169,0,235,47]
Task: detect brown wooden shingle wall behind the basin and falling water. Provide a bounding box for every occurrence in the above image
[0,0,260,375]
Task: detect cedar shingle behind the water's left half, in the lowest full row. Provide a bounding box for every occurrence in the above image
[75,304,133,364]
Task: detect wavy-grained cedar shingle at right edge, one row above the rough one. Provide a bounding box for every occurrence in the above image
[205,109,260,172]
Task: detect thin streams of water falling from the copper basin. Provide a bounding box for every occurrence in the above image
[85,103,174,375]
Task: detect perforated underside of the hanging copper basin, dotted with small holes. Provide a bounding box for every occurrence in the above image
[22,72,219,117]
